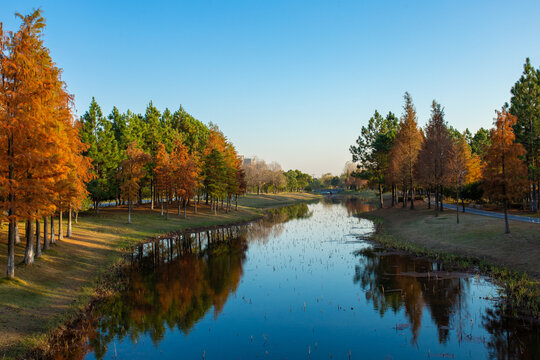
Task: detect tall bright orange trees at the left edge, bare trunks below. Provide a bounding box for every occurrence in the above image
[0,10,92,278]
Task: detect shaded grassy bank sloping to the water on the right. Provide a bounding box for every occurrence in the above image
[358,198,540,315]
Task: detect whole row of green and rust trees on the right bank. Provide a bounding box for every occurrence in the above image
[350,59,540,232]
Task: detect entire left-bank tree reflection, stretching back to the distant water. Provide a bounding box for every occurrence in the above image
[56,203,312,359]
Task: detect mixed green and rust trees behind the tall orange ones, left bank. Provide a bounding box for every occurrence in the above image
[81,98,246,221]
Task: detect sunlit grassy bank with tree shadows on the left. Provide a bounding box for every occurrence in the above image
[0,194,316,358]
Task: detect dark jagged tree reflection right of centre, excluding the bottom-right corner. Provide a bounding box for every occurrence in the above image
[354,250,469,343]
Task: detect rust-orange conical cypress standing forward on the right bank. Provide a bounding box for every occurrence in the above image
[483,107,527,233]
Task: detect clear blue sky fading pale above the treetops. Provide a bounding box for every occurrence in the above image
[0,0,540,175]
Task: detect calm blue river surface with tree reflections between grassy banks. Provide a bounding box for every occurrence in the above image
[69,200,540,359]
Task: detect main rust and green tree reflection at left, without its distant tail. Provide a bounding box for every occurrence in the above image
[89,237,247,358]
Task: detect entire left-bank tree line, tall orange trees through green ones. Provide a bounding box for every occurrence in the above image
[0,10,247,278]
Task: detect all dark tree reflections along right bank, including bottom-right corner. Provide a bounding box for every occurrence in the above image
[354,249,540,359]
